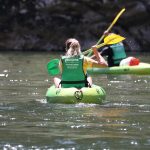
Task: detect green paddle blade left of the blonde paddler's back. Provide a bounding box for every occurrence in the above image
[47,59,60,76]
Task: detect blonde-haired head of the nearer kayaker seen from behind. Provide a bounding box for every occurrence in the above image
[65,38,81,56]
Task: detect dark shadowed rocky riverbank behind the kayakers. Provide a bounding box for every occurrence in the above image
[0,0,150,52]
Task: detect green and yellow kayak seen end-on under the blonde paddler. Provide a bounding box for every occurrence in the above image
[46,85,106,104]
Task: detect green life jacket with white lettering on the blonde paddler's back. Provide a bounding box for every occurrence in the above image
[61,55,86,88]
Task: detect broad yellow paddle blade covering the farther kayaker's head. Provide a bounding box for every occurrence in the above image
[104,33,125,45]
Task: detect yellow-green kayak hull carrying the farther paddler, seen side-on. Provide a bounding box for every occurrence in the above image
[88,63,150,75]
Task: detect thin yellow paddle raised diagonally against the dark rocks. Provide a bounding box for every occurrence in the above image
[85,8,125,56]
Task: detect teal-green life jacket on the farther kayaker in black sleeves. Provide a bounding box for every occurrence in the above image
[110,43,127,64]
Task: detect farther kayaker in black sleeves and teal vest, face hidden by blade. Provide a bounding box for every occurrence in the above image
[98,31,127,67]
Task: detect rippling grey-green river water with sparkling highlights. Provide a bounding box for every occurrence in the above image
[0,52,150,150]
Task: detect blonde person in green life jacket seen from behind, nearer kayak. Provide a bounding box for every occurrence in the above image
[54,38,108,89]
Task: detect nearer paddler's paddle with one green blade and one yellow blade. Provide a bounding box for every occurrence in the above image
[47,34,125,76]
